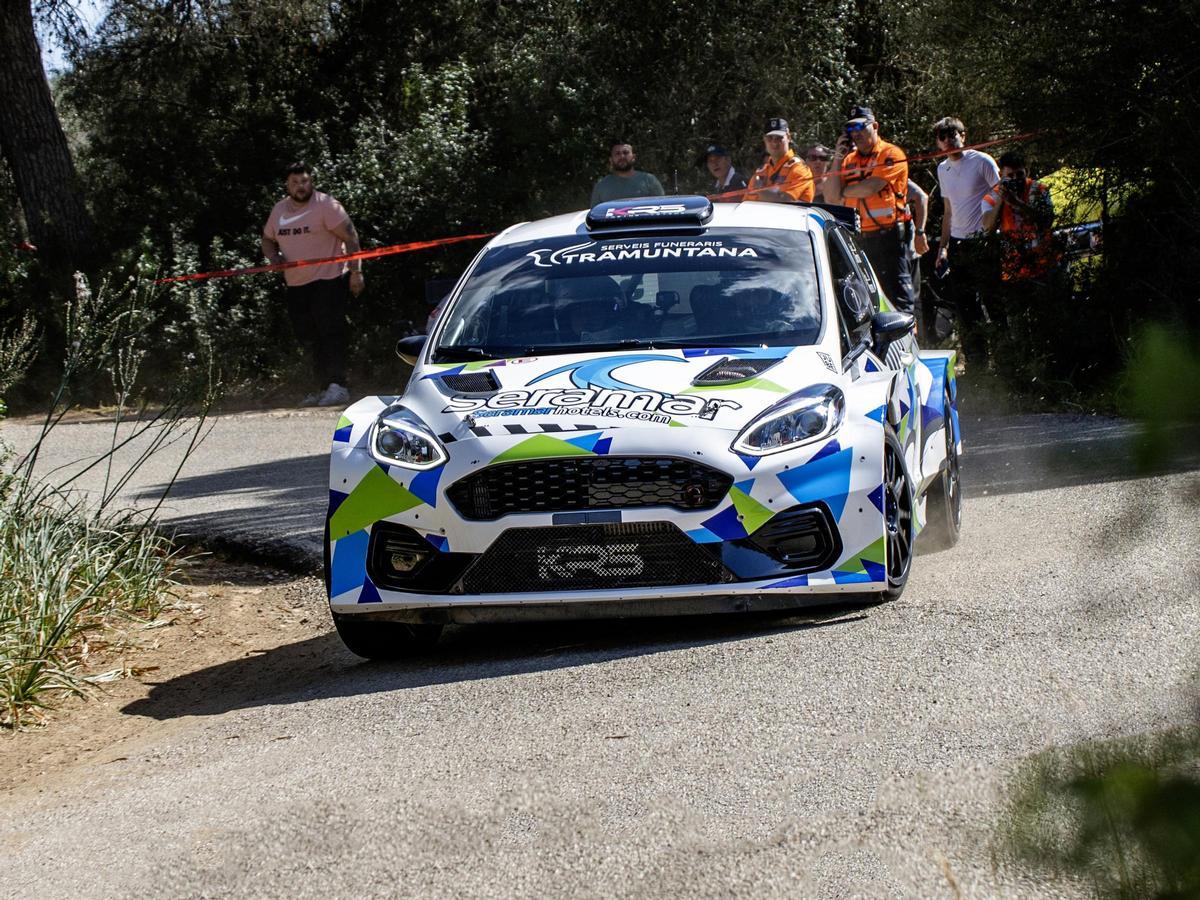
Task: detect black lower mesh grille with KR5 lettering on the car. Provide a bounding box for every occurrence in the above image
[463,522,733,594]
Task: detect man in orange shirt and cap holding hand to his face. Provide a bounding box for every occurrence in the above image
[826,107,913,312]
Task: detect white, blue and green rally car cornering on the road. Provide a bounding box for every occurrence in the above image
[325,197,961,658]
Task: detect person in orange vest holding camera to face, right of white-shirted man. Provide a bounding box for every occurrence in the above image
[982,151,1057,281]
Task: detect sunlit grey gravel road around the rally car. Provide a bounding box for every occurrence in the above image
[0,412,1200,898]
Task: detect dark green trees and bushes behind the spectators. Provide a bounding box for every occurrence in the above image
[0,0,1200,408]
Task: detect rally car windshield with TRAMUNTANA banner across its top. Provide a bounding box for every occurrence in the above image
[433,228,821,361]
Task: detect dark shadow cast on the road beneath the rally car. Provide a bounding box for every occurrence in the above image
[121,606,871,720]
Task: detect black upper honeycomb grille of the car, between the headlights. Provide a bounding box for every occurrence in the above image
[446,456,733,521]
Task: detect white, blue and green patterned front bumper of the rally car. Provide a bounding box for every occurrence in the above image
[326,408,887,620]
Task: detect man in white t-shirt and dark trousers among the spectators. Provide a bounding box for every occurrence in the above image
[934,116,1000,362]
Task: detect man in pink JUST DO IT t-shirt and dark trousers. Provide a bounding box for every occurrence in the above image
[263,162,362,406]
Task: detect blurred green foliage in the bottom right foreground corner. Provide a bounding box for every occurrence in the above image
[995,726,1200,898]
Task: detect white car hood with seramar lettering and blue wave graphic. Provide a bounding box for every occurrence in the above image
[398,347,844,438]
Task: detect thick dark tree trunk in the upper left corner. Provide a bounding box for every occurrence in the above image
[0,0,97,274]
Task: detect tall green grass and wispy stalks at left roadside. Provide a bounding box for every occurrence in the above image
[0,276,217,727]
